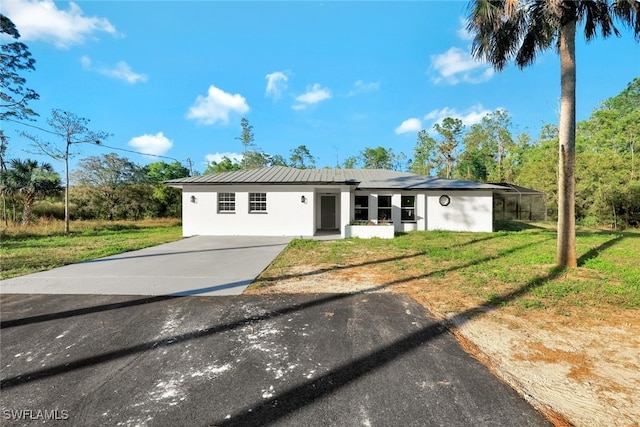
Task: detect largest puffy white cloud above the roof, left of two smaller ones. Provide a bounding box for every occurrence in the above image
[187,85,249,125]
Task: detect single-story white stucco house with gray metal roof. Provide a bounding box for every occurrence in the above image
[166,166,516,237]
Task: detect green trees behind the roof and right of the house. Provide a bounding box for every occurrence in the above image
[204,78,640,229]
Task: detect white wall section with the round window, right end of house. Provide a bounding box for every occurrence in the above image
[426,190,493,231]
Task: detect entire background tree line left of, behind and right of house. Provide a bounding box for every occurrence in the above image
[0,18,640,228]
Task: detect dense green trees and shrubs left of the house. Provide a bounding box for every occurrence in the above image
[0,153,189,225]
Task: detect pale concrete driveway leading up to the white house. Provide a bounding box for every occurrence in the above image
[0,236,291,295]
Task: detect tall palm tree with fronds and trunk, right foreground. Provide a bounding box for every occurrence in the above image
[467,0,640,267]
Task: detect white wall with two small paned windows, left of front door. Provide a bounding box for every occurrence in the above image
[182,185,319,236]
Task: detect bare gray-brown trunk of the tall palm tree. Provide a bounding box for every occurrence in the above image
[556,19,578,267]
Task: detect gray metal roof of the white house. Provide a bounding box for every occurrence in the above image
[166,166,502,190]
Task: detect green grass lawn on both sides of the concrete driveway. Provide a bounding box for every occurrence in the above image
[0,220,640,312]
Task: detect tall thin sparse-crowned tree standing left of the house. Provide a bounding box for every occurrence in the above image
[22,109,111,234]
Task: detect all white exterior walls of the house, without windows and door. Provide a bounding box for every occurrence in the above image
[182,185,493,237]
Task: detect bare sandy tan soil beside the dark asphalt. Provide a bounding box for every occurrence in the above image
[248,266,640,427]
